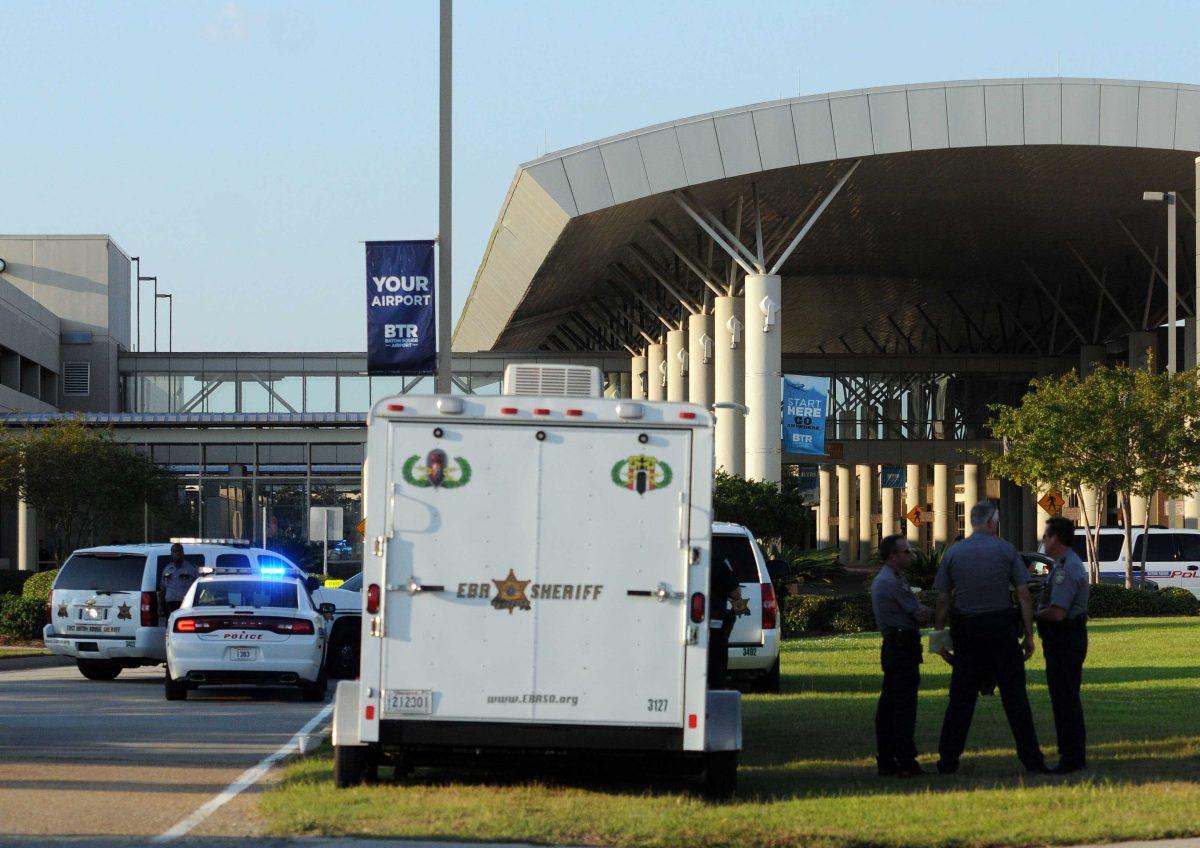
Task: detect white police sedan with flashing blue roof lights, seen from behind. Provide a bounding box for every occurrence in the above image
[164,564,334,700]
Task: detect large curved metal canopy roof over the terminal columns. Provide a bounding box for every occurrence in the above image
[454,78,1200,355]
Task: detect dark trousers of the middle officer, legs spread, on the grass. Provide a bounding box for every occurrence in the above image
[937,613,1045,769]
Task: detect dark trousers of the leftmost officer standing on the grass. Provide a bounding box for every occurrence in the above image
[875,630,920,769]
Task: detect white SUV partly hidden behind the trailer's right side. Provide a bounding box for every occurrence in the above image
[713,522,782,693]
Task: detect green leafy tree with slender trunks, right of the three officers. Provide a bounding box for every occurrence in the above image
[984,366,1200,587]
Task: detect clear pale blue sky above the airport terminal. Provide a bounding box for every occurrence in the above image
[0,0,1200,350]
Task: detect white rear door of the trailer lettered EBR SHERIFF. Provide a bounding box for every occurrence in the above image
[382,422,691,727]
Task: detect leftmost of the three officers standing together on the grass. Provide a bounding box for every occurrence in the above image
[871,535,934,777]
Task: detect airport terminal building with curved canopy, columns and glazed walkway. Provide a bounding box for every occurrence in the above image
[0,78,1200,567]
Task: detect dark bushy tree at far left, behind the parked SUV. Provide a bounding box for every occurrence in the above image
[0,419,174,563]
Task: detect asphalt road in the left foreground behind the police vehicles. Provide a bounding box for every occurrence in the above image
[0,660,332,843]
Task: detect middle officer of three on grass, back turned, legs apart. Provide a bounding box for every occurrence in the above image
[934,500,1046,774]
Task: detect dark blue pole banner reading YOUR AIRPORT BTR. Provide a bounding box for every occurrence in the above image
[367,240,438,375]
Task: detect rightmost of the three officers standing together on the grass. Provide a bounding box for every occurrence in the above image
[1034,518,1091,775]
